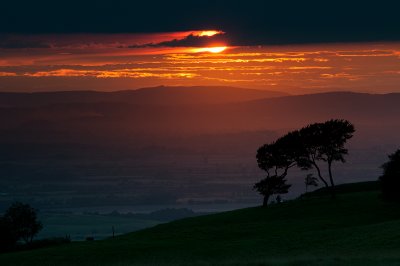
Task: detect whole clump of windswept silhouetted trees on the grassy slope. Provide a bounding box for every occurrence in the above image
[254,119,355,205]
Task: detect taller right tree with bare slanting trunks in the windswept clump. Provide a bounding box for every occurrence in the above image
[297,119,355,197]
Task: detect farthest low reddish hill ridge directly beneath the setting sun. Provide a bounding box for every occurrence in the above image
[0,86,288,107]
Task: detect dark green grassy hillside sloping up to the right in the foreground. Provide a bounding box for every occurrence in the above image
[0,184,400,266]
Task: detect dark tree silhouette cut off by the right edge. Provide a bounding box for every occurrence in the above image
[379,149,400,201]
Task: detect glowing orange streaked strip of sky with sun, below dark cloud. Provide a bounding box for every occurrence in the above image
[0,30,400,94]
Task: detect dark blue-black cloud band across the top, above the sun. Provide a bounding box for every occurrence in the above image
[0,0,400,45]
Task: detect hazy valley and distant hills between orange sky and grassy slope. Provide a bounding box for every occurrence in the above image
[0,87,400,214]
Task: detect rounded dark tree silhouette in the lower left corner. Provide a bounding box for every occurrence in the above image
[3,202,43,243]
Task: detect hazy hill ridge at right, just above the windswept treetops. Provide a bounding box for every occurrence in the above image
[231,92,400,128]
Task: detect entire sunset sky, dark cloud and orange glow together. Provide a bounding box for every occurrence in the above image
[0,1,400,94]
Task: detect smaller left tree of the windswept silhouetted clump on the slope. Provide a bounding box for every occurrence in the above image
[254,132,299,206]
